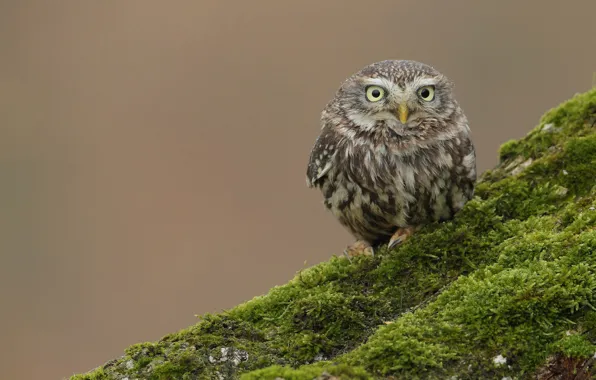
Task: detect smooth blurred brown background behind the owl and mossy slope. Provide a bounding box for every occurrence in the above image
[0,0,596,379]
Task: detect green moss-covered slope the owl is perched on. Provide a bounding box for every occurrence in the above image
[72,89,596,380]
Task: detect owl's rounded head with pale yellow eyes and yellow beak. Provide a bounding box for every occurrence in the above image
[334,60,458,135]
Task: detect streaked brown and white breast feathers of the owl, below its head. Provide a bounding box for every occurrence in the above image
[322,139,464,239]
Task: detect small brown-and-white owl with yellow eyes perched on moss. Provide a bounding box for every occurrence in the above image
[306,60,476,258]
